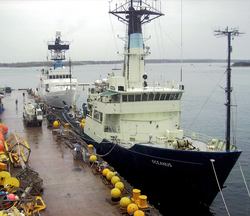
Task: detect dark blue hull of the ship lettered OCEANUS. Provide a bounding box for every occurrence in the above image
[81,134,241,212]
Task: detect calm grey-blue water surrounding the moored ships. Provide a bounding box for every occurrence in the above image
[0,63,250,216]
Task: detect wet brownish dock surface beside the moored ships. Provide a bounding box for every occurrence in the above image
[0,90,125,216]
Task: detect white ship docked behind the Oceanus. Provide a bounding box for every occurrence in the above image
[36,31,79,108]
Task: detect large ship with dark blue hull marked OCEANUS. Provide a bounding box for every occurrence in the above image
[79,0,241,211]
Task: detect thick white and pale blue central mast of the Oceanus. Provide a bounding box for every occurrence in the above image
[109,0,164,88]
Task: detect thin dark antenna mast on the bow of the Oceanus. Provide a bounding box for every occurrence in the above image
[214,27,244,151]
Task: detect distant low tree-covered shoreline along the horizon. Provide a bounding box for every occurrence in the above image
[0,59,250,67]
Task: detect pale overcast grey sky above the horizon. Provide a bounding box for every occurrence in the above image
[0,0,250,63]
